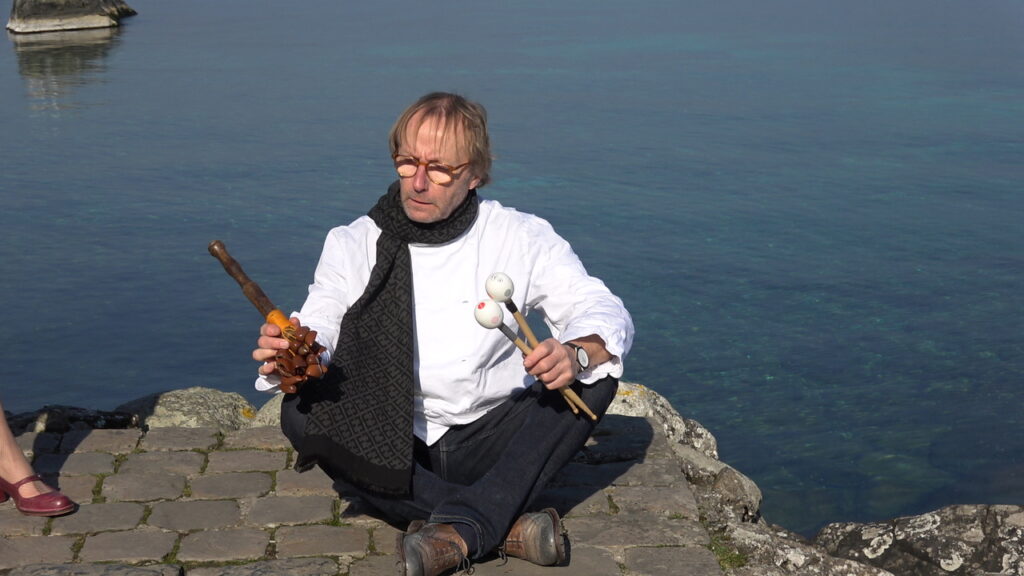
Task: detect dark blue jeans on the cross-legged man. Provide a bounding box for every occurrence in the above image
[281,377,618,558]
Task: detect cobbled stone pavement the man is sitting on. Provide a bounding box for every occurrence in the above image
[0,414,722,576]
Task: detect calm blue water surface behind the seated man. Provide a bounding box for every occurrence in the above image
[0,0,1024,533]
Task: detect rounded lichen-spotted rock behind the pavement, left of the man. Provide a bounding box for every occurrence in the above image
[116,387,256,431]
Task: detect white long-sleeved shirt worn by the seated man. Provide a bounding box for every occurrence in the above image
[256,200,633,445]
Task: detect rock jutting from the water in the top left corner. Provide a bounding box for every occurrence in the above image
[7,0,136,34]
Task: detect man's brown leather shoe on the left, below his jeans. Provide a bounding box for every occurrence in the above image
[398,524,469,576]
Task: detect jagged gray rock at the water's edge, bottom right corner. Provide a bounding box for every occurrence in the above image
[815,505,1024,576]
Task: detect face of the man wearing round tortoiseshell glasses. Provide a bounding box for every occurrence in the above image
[397,115,480,223]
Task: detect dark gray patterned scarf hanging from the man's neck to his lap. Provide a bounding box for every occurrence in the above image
[296,181,479,496]
